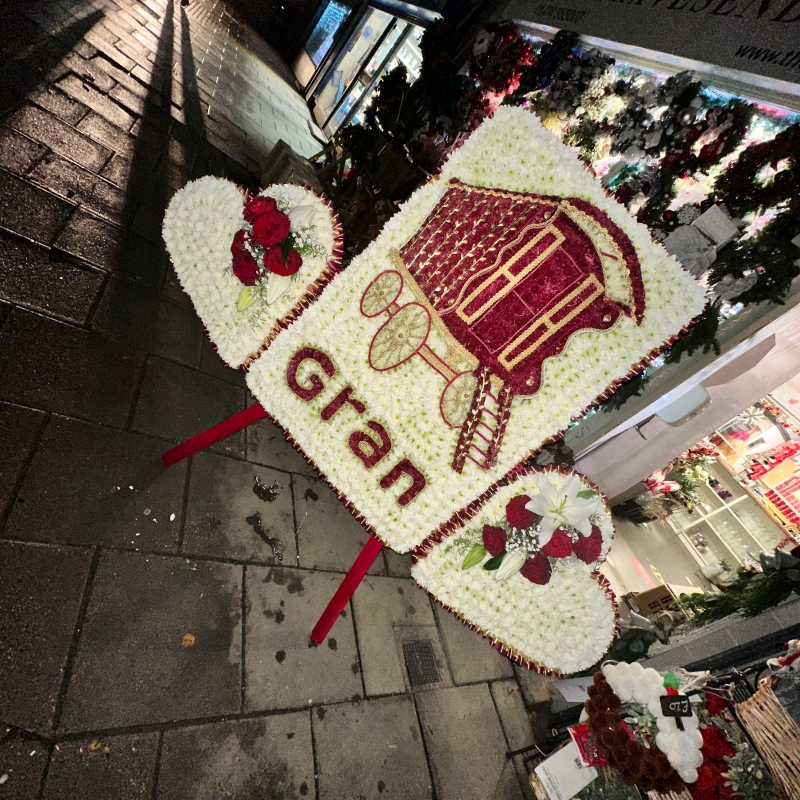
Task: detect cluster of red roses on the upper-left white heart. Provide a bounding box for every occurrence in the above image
[231,195,303,286]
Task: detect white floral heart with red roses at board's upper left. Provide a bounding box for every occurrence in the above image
[163,176,342,367]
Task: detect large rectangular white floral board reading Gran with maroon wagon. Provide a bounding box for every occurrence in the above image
[247,107,703,552]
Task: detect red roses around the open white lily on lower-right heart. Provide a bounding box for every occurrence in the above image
[483,494,603,586]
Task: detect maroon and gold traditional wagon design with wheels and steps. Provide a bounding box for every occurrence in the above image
[361,180,645,472]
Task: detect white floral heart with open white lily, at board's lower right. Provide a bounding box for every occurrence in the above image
[411,470,617,674]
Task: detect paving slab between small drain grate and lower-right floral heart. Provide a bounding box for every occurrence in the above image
[433,603,514,683]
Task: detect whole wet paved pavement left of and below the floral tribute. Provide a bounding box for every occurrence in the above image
[0,0,552,800]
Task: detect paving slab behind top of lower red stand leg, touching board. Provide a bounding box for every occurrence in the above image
[294,476,384,575]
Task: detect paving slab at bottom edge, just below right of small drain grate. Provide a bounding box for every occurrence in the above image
[416,684,522,800]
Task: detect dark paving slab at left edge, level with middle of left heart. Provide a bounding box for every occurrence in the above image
[0,227,104,324]
